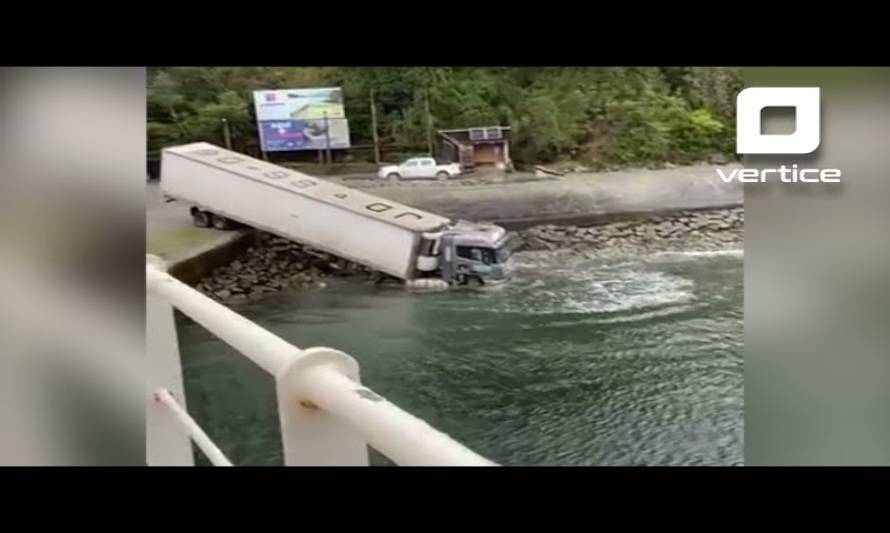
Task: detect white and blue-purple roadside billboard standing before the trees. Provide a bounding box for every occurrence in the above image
[253,87,350,152]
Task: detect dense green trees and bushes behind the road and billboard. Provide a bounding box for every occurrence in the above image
[148,67,741,168]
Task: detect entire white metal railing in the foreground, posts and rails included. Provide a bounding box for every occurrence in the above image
[146,256,495,466]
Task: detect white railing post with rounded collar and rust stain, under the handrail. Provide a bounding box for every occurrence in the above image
[275,348,369,466]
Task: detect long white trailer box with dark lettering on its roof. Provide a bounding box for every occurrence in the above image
[161,143,447,279]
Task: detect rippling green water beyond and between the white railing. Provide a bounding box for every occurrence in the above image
[180,253,743,465]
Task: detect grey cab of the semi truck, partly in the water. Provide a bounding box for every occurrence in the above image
[439,221,511,285]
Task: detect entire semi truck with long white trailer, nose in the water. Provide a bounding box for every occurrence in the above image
[161,139,510,286]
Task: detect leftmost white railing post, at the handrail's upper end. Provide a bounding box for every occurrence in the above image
[145,255,195,466]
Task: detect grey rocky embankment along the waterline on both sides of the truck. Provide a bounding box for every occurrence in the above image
[196,207,745,303]
